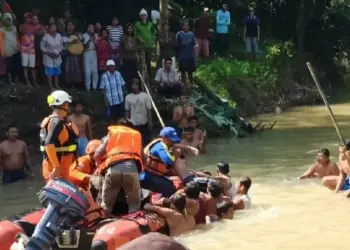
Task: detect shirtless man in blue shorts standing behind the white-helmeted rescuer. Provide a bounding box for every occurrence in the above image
[67,102,92,156]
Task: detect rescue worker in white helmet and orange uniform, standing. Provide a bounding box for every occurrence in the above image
[40,90,79,182]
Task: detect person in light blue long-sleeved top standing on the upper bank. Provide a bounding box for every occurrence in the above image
[216,4,231,56]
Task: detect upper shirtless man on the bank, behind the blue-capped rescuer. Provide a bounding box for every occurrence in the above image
[173,95,194,138]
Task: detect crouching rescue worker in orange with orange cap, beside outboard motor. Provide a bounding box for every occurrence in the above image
[69,140,102,189]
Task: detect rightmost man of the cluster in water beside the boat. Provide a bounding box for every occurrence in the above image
[233,177,252,210]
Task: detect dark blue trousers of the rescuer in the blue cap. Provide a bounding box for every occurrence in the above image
[139,171,176,197]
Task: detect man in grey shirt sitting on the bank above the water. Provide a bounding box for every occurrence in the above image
[154,58,182,96]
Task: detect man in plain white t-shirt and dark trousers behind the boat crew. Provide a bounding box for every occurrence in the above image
[125,79,152,146]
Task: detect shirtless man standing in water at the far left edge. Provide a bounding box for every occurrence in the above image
[0,125,32,184]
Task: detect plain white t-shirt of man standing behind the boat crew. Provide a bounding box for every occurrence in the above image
[125,92,152,126]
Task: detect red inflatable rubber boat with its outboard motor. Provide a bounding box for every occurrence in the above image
[0,177,183,250]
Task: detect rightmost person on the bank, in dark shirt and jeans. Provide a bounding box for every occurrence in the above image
[243,7,260,59]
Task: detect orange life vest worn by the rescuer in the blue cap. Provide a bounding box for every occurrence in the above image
[143,138,170,175]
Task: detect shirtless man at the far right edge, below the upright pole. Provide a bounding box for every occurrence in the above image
[322,143,350,194]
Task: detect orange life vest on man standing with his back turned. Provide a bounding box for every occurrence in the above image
[99,125,143,174]
